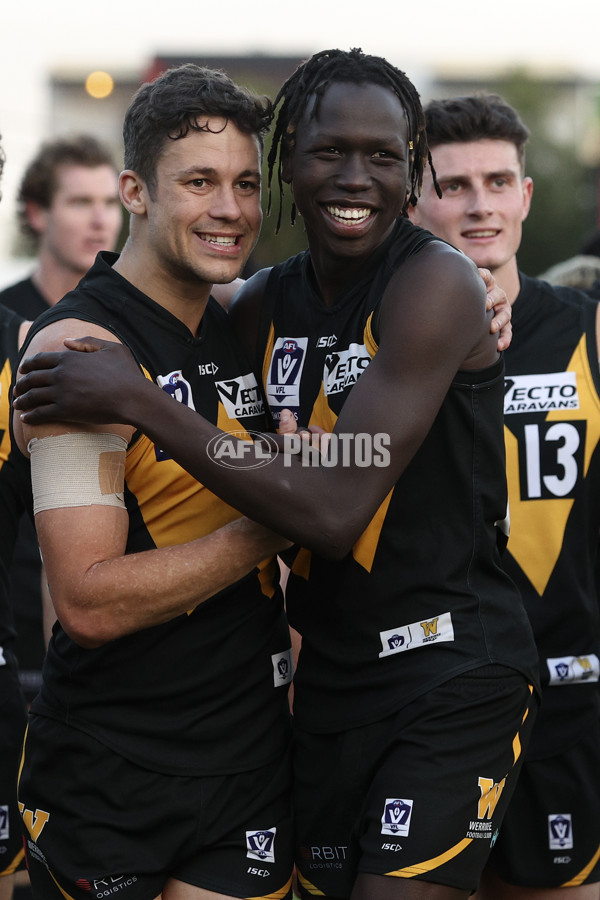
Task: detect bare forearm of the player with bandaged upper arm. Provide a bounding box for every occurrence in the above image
[42,518,288,648]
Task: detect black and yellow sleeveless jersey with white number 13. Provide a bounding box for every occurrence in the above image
[504,275,600,756]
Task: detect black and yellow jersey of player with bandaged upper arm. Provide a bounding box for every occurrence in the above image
[22,253,291,775]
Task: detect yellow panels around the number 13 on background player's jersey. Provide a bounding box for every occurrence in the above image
[504,336,600,596]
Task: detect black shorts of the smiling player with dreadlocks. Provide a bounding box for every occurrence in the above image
[294,666,538,898]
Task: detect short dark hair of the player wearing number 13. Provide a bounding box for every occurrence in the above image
[425,93,529,171]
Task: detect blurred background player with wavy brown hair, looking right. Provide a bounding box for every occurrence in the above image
[0,134,122,701]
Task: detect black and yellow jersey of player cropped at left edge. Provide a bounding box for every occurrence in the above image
[0,305,27,666]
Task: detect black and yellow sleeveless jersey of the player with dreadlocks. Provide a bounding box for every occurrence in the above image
[255,219,536,732]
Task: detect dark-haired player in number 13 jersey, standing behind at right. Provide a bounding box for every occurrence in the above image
[411,95,600,900]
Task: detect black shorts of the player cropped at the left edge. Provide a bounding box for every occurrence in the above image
[0,666,27,876]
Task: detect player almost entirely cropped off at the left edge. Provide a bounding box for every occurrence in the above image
[0,135,29,900]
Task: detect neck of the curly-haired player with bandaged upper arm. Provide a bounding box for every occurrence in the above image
[113,241,212,336]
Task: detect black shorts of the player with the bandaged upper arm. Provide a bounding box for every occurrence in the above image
[19,716,293,900]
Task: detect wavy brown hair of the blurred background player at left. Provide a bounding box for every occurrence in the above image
[18,134,117,238]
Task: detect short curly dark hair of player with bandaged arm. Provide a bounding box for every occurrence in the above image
[123,63,273,194]
